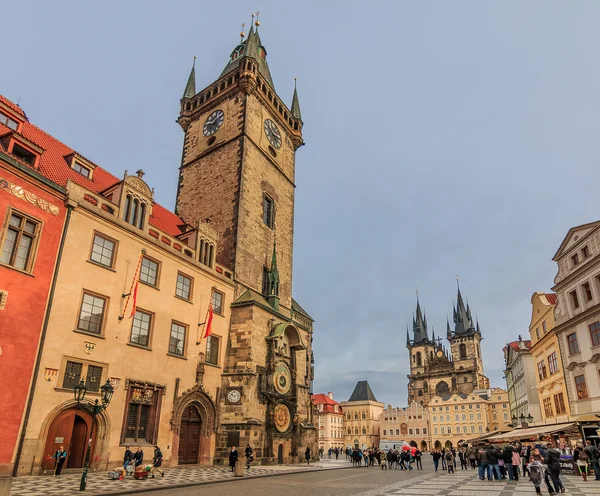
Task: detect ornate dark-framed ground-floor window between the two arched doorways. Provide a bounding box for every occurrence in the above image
[121,381,164,444]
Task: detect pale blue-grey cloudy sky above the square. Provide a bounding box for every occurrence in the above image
[0,0,600,406]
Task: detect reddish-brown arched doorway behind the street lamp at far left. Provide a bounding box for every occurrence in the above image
[42,408,97,470]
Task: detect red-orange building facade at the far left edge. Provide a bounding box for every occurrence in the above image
[0,156,66,475]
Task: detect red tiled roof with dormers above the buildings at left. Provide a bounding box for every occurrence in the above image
[0,95,184,236]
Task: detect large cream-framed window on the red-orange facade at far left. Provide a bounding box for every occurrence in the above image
[0,212,40,273]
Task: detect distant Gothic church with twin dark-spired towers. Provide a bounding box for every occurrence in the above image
[406,288,489,406]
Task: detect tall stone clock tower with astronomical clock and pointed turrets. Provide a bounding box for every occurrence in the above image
[176,21,317,463]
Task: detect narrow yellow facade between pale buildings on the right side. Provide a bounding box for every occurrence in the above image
[529,292,570,422]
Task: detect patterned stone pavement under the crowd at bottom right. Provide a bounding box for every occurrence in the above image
[370,470,600,496]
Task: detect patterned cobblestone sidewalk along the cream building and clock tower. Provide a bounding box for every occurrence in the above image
[10,461,349,496]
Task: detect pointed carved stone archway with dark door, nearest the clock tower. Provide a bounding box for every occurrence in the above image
[170,384,217,465]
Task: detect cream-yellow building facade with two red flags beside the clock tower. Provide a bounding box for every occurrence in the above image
[19,177,233,473]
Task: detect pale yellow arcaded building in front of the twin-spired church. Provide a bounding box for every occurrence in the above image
[429,388,511,449]
